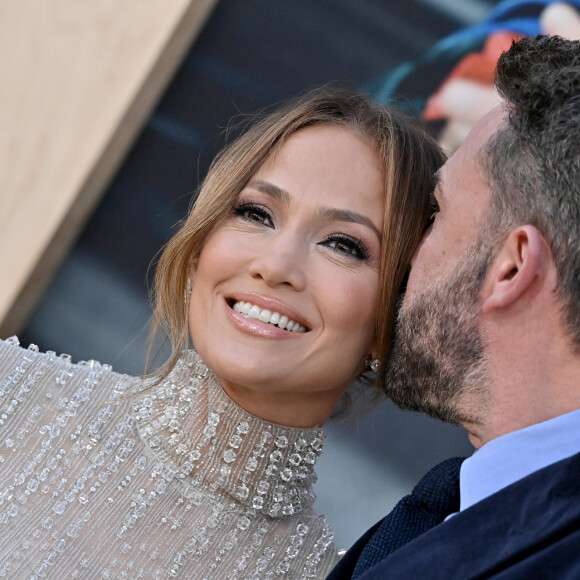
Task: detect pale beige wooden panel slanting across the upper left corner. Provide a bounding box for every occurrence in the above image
[0,0,216,337]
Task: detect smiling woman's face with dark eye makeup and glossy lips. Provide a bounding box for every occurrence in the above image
[189,125,384,427]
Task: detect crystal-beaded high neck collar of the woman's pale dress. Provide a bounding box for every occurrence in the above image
[133,351,324,518]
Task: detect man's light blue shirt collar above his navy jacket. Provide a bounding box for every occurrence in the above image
[459,409,580,511]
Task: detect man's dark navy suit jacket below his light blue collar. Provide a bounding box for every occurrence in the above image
[332,453,580,580]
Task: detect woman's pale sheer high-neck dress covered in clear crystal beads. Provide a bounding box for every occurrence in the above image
[0,339,338,580]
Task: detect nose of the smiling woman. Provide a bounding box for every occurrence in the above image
[250,237,306,292]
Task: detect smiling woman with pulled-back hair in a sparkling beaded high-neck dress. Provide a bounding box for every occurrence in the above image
[0,90,443,579]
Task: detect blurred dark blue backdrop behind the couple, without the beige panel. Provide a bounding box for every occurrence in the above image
[5,0,580,548]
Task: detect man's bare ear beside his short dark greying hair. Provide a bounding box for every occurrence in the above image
[482,225,551,314]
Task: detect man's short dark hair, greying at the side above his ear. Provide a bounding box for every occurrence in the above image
[481,36,580,351]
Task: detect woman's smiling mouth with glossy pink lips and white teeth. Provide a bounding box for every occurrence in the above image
[227,297,309,336]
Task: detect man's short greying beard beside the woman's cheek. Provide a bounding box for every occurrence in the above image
[382,240,492,424]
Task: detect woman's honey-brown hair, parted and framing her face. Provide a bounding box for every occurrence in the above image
[153,89,444,394]
